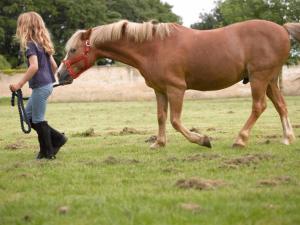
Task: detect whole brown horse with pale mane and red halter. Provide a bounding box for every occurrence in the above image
[57,20,300,148]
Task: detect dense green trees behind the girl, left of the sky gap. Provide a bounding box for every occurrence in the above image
[0,0,180,67]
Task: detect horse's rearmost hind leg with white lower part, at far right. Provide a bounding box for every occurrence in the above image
[267,79,295,145]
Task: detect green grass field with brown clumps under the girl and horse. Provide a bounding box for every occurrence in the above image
[0,97,300,225]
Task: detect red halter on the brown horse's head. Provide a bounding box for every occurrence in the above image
[62,40,91,79]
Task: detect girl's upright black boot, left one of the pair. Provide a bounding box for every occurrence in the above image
[34,121,55,159]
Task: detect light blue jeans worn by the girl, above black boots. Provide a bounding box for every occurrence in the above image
[25,83,53,123]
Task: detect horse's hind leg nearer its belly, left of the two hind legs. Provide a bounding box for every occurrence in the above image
[233,71,270,147]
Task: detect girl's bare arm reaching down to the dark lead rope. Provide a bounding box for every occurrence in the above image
[9,55,39,91]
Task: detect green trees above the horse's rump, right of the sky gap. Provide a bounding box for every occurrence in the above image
[191,0,300,63]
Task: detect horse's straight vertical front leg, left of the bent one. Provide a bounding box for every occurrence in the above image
[150,91,168,149]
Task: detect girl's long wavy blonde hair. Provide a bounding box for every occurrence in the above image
[16,12,54,55]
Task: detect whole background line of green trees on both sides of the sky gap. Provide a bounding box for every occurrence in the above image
[0,0,300,69]
